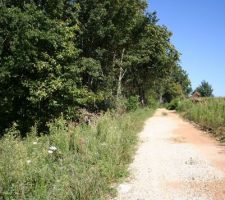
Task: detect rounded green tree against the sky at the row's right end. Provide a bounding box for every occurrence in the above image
[126,19,187,102]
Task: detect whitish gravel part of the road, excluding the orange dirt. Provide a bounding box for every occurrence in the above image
[115,110,225,200]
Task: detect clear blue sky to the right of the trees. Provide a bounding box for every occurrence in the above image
[148,0,225,96]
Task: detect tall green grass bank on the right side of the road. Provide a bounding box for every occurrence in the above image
[176,98,225,141]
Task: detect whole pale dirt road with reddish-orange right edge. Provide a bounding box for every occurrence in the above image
[116,109,225,200]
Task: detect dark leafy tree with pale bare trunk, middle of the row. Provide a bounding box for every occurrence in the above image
[76,0,147,98]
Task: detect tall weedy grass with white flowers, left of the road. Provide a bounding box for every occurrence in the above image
[0,109,153,200]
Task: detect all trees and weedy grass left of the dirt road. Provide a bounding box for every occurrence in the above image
[0,0,191,200]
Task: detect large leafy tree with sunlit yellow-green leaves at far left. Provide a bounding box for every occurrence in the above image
[0,4,97,134]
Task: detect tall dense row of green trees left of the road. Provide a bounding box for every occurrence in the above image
[0,0,191,135]
